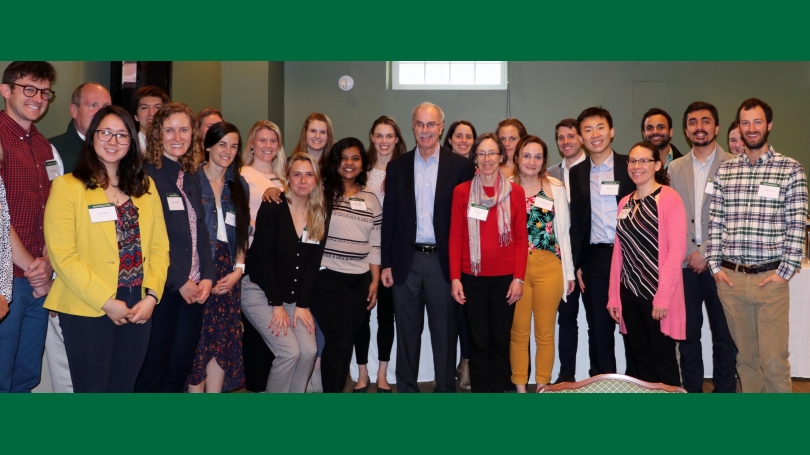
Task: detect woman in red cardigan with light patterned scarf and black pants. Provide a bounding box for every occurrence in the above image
[449,133,528,393]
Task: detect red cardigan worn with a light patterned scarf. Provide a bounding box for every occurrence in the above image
[449,181,529,280]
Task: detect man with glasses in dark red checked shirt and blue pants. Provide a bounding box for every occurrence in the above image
[0,62,61,392]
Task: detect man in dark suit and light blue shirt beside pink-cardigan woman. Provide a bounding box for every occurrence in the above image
[569,107,636,376]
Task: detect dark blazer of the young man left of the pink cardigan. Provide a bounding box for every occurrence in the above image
[568,152,636,270]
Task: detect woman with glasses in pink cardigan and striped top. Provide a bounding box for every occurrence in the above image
[607,142,686,386]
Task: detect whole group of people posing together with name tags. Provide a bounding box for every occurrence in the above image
[0,62,807,393]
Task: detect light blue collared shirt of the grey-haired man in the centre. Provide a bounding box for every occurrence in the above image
[413,143,441,245]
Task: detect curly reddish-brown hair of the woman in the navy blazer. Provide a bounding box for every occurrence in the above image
[144,103,204,174]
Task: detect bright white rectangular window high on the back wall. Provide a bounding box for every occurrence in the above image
[391,61,507,90]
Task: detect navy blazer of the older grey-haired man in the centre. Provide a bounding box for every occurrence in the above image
[381,147,475,284]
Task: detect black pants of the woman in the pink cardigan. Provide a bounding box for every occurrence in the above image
[619,286,681,387]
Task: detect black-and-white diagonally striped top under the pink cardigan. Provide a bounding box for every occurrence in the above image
[616,187,661,300]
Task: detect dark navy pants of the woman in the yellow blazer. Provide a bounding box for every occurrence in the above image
[59,286,152,393]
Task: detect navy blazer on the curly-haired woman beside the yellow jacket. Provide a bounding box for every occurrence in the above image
[143,158,217,292]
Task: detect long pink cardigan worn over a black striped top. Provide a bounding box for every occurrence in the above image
[607,185,686,340]
